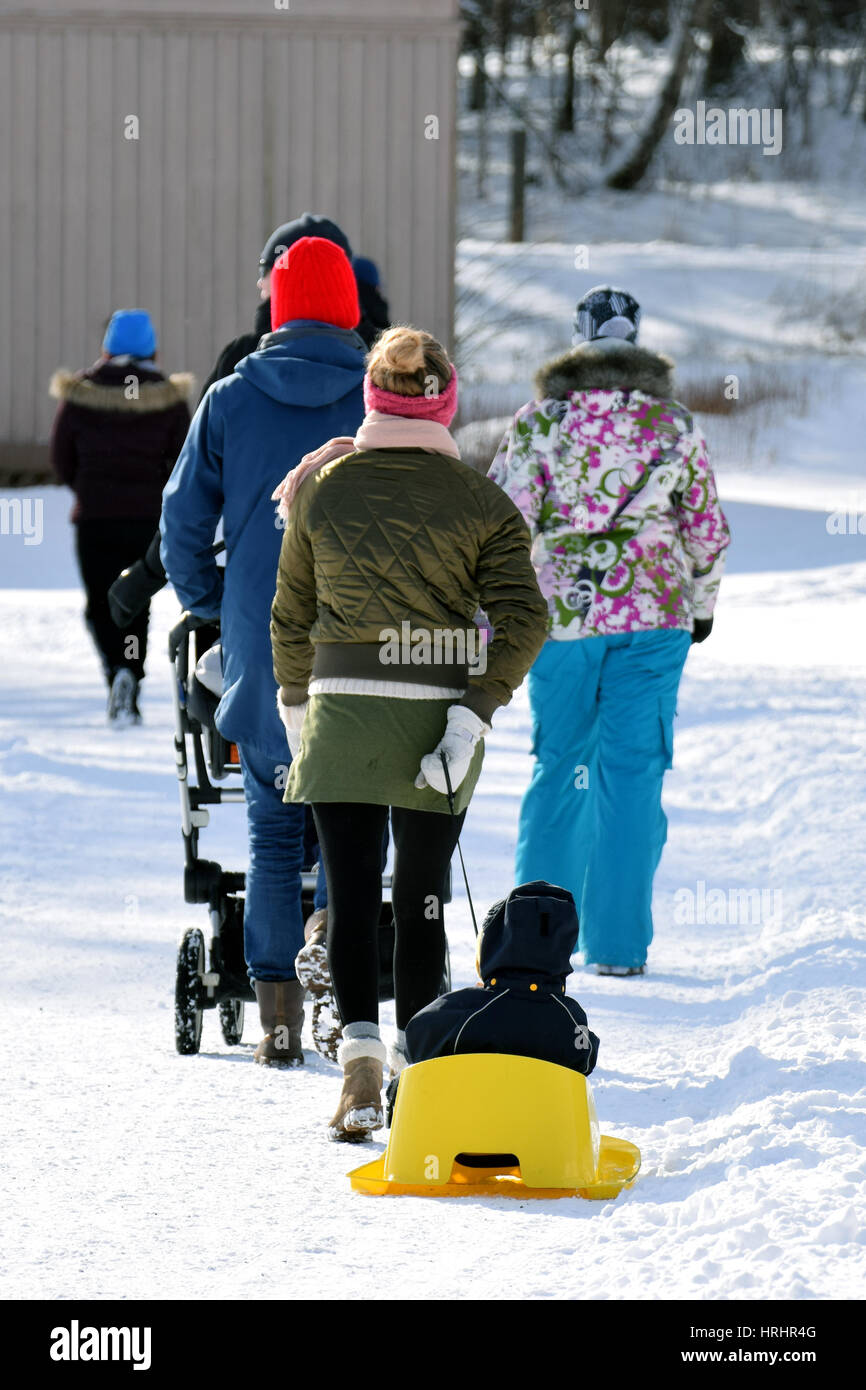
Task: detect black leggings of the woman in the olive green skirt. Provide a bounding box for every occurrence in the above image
[313,802,466,1029]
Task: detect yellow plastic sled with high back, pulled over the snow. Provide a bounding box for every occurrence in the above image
[349,1052,641,1200]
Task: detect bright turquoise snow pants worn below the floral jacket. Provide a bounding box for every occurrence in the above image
[516,628,691,966]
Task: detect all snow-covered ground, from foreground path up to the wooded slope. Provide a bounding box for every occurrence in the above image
[0,118,866,1300]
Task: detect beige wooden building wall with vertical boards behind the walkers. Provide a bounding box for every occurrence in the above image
[0,0,459,477]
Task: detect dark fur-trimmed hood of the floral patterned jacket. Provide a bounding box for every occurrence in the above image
[535,338,674,400]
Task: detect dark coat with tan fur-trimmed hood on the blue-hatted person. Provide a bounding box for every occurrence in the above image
[50,357,193,525]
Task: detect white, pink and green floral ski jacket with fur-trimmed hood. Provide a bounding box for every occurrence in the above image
[489,339,730,641]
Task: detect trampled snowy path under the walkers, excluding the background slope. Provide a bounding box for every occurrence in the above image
[0,491,866,1298]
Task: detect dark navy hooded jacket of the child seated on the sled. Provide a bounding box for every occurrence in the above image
[406,883,598,1076]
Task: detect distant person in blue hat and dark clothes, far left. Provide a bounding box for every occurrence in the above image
[49,309,193,728]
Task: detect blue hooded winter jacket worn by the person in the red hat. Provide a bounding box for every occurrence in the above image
[161,321,364,762]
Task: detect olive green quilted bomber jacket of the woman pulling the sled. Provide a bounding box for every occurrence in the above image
[271,449,548,721]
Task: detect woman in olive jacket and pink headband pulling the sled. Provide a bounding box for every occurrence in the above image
[271,327,546,1141]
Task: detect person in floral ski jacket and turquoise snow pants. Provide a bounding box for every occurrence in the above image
[489,286,730,974]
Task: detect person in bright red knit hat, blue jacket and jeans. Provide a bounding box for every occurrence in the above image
[160,236,366,1065]
